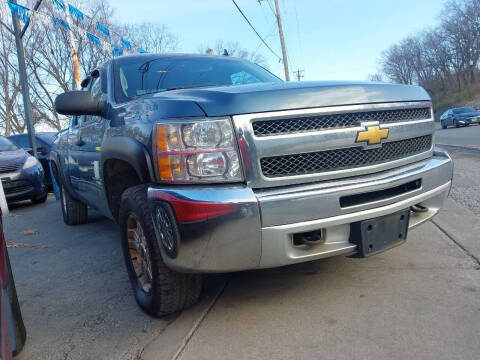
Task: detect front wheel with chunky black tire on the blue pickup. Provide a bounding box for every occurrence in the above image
[119,185,202,316]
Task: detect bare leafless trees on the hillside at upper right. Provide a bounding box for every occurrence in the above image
[380,0,480,100]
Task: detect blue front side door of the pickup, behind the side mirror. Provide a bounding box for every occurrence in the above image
[77,76,109,216]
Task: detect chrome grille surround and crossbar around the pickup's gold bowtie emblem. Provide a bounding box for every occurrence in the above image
[232,101,435,189]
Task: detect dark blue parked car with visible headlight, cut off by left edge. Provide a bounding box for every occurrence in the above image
[0,136,48,204]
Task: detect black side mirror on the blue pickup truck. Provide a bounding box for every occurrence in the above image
[55,90,105,115]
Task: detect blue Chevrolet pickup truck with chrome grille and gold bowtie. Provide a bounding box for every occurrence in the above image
[51,54,452,316]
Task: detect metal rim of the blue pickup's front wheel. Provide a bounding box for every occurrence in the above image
[127,214,152,294]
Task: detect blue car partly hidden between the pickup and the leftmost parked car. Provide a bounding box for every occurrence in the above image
[8,132,57,190]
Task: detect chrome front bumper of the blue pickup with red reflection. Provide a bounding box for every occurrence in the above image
[148,151,453,272]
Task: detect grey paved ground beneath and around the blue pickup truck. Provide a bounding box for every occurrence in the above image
[4,126,480,360]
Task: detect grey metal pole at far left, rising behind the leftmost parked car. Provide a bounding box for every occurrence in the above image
[11,0,37,157]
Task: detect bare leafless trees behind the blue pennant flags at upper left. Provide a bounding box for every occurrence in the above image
[0,0,180,135]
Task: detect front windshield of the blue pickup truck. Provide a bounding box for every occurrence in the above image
[115,56,281,102]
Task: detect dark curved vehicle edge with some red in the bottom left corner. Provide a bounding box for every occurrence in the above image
[0,210,26,360]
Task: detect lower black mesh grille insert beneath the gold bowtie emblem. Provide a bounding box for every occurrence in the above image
[260,135,432,177]
